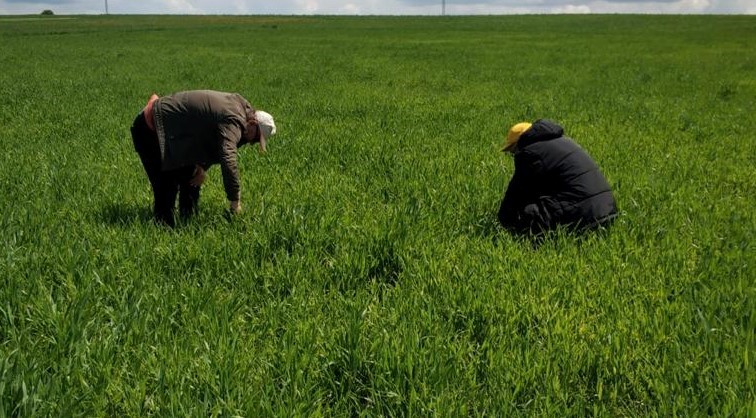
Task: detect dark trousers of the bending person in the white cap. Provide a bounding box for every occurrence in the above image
[131,113,200,226]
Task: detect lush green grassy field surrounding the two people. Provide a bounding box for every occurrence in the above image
[0,16,756,417]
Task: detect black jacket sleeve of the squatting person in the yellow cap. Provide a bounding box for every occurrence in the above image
[498,151,541,232]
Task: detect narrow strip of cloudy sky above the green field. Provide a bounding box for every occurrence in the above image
[0,0,756,15]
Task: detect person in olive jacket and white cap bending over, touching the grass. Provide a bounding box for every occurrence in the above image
[131,90,276,226]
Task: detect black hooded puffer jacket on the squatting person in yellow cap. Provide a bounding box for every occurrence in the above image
[499,119,617,233]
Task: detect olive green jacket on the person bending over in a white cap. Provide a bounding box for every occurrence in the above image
[153,90,254,201]
